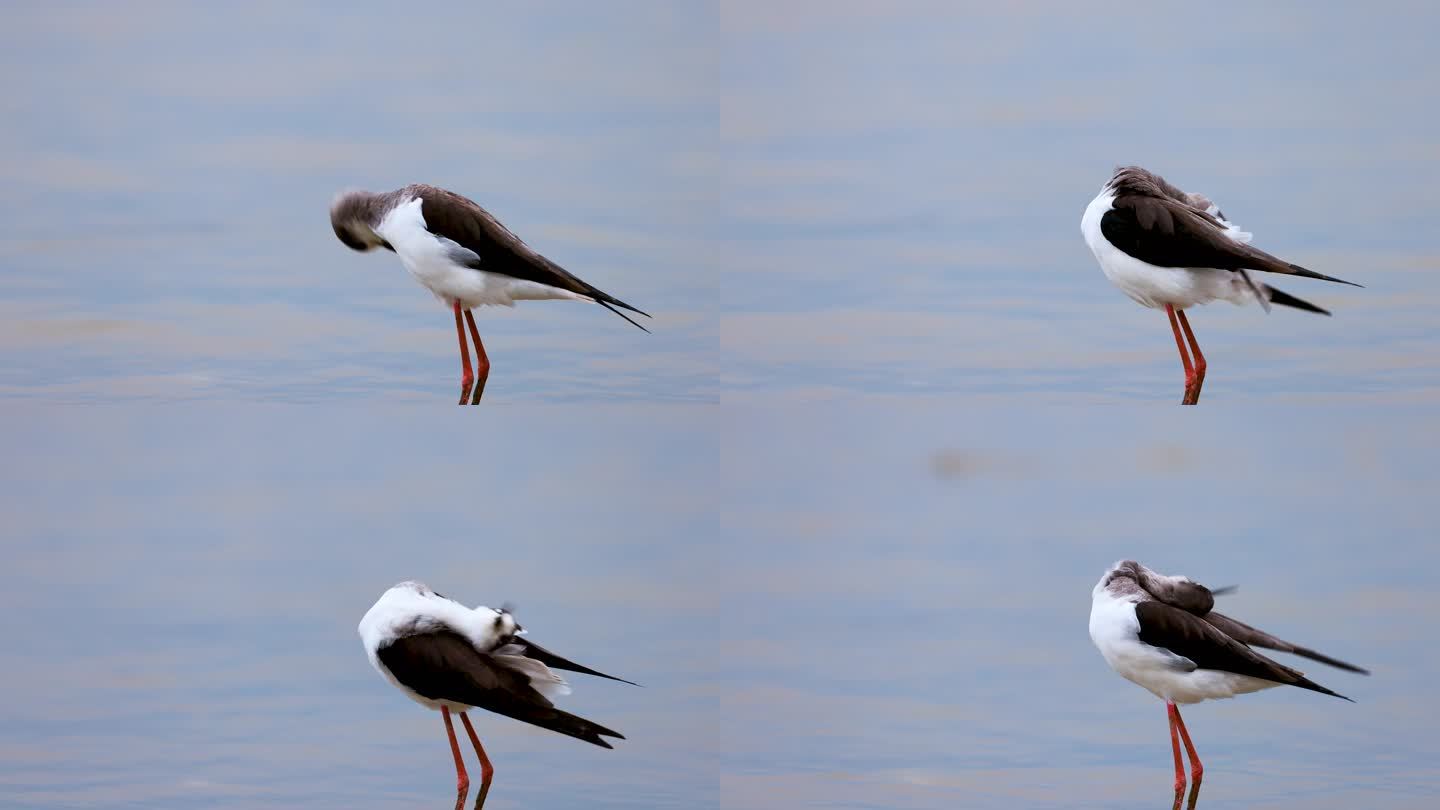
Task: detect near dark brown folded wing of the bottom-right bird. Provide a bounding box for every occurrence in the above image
[1135,601,1349,700]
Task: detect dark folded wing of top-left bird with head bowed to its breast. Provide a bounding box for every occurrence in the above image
[408,186,649,331]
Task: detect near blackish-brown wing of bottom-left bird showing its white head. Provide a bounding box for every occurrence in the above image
[377,630,625,748]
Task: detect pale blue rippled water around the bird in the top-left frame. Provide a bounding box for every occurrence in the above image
[0,3,717,402]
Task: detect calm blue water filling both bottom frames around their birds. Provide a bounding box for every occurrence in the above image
[0,402,1440,810]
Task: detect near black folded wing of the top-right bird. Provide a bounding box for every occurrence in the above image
[1100,195,1359,287]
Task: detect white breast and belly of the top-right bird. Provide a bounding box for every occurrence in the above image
[1080,190,1254,310]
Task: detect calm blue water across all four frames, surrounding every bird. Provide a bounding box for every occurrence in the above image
[0,1,1440,810]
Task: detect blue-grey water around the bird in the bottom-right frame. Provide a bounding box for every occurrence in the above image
[716,398,1440,810]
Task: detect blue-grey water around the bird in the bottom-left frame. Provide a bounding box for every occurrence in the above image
[0,404,720,810]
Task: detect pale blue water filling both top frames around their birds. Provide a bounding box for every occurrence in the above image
[0,0,1440,404]
